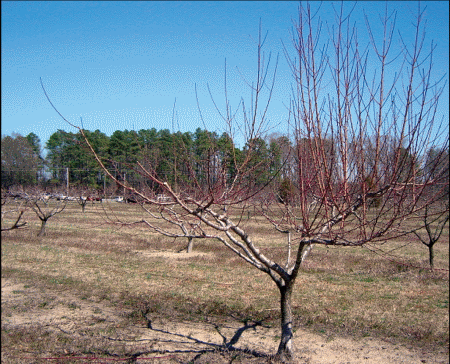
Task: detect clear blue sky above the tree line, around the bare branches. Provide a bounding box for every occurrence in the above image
[1,1,449,152]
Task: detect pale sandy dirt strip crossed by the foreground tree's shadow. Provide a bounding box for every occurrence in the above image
[1,279,449,364]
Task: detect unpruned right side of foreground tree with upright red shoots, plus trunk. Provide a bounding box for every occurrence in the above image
[264,5,448,351]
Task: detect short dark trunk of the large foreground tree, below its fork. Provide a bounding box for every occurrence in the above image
[277,285,294,363]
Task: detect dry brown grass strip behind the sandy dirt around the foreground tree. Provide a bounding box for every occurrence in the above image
[2,203,449,347]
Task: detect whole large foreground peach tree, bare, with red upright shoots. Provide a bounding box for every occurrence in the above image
[44,5,448,362]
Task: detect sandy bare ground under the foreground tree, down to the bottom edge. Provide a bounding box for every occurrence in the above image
[2,278,448,364]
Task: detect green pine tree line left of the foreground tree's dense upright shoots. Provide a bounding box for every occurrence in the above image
[2,128,291,192]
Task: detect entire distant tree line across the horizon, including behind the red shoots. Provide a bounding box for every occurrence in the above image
[1,128,448,201]
